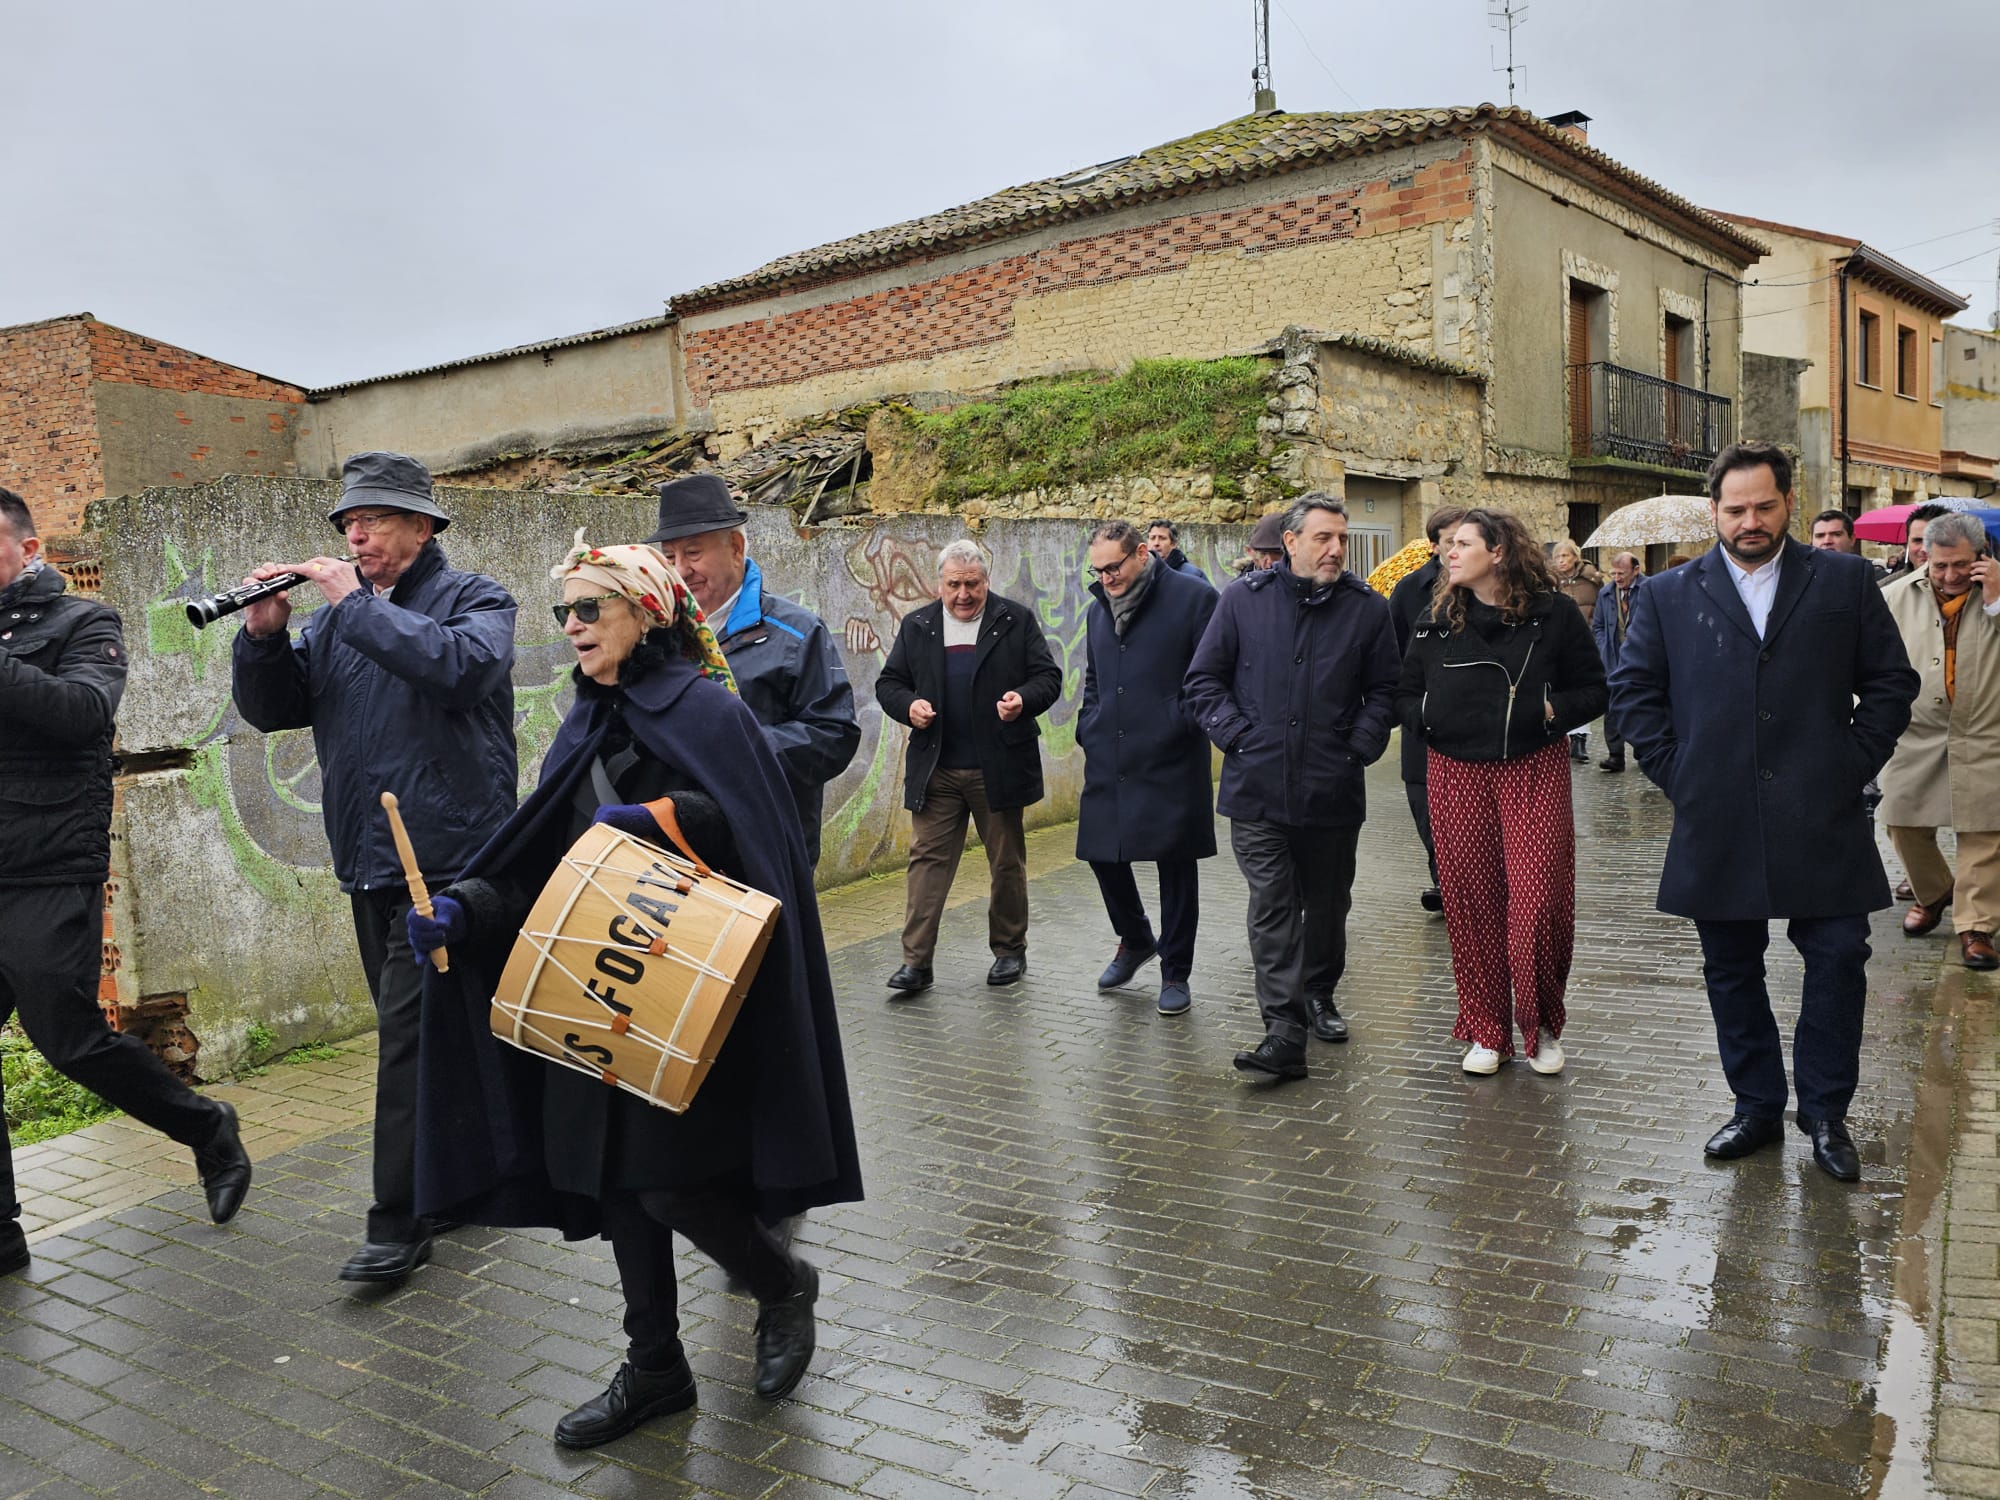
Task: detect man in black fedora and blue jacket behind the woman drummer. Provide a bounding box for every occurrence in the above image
[646,474,862,864]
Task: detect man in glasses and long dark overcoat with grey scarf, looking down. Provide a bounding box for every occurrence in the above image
[1076,520,1216,1016]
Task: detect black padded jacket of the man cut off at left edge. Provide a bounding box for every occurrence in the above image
[0,564,126,886]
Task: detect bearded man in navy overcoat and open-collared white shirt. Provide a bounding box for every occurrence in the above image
[1610,442,1918,1182]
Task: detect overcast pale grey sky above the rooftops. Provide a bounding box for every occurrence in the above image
[0,0,2000,386]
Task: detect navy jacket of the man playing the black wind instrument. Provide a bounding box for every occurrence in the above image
[234,542,520,892]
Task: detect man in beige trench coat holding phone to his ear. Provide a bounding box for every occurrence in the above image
[1882,514,2000,968]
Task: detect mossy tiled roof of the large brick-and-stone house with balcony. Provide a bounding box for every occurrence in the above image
[672,104,1764,314]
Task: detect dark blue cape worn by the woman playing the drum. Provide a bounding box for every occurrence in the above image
[416,656,862,1238]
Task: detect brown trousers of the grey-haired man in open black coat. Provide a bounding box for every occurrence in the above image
[902,766,1028,968]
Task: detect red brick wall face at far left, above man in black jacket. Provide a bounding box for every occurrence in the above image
[0,318,104,536]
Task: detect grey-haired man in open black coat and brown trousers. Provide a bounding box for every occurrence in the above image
[876,540,1062,996]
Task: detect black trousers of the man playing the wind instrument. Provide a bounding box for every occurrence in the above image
[350,888,424,1244]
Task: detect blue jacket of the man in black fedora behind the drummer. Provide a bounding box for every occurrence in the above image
[716,558,862,864]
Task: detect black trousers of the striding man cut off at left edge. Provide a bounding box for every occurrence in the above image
[0,884,220,1220]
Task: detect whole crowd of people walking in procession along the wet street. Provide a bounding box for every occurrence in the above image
[0,432,1976,1448]
